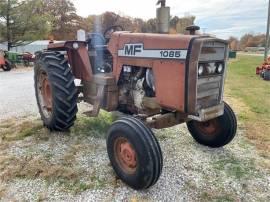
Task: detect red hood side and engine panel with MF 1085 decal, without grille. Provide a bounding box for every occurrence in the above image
[109,32,196,112]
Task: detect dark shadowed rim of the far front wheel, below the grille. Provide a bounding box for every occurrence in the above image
[196,118,220,136]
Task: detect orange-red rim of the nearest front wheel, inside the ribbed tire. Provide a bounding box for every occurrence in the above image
[114,137,137,174]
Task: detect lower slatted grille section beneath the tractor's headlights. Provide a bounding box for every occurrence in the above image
[197,75,223,110]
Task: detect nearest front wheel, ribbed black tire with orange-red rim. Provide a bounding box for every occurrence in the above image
[107,117,163,190]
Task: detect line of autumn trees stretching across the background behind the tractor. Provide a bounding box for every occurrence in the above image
[0,0,265,50]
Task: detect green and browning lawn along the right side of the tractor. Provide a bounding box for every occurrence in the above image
[225,56,270,156]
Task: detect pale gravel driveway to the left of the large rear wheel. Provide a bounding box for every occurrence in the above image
[0,69,38,120]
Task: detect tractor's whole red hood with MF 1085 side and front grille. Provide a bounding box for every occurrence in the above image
[108,32,228,116]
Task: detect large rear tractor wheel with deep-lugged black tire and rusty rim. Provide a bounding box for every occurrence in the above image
[34,52,78,131]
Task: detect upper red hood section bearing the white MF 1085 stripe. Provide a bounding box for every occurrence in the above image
[109,32,198,60]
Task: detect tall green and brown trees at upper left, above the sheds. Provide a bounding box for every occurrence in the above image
[0,0,84,49]
